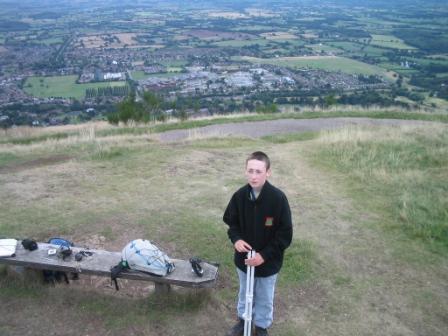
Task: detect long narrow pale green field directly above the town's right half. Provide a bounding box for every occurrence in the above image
[233,56,385,76]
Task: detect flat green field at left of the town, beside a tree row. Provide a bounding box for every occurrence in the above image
[23,75,126,99]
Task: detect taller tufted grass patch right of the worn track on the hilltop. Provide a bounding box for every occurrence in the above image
[318,124,448,247]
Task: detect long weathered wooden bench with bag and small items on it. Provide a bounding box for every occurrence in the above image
[0,241,218,292]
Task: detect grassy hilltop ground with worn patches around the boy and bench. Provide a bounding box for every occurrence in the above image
[0,117,448,336]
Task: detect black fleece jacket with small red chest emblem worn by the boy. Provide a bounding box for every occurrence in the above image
[223,181,292,277]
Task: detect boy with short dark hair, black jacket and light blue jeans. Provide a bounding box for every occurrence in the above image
[223,152,292,336]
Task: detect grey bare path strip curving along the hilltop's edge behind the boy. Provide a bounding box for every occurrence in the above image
[155,118,431,142]
